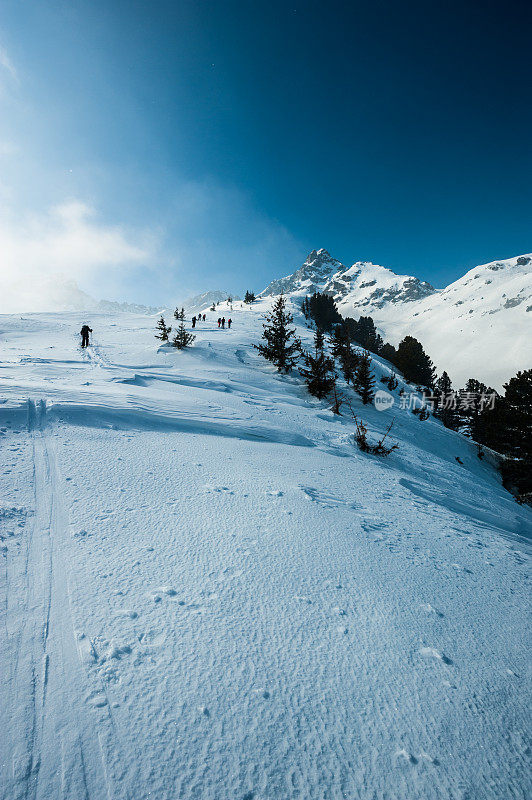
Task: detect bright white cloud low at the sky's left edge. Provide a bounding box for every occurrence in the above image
[0,200,154,313]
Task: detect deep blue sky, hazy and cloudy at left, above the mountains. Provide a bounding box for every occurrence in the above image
[0,0,532,303]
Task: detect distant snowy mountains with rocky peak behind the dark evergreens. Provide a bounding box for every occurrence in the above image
[263,250,532,390]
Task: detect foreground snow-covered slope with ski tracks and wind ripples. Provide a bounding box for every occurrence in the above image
[0,300,532,800]
